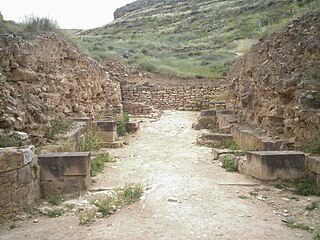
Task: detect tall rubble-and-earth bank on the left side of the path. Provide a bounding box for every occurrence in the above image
[0,33,122,138]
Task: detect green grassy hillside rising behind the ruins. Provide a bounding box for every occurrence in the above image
[80,0,320,78]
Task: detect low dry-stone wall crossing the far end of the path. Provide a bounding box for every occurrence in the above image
[121,81,225,115]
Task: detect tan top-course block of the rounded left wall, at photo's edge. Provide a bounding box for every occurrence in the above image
[0,148,24,173]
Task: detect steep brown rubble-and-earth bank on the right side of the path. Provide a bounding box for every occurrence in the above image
[228,15,320,142]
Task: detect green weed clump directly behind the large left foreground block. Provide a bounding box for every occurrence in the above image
[77,130,102,152]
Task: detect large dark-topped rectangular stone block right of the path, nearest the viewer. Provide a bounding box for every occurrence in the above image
[244,151,306,181]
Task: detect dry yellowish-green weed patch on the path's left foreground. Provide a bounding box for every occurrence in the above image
[95,184,143,217]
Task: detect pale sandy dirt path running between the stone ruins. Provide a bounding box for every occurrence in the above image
[0,111,312,240]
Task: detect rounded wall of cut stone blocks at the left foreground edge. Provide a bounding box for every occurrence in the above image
[0,146,40,218]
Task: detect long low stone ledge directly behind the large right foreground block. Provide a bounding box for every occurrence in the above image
[231,124,286,151]
